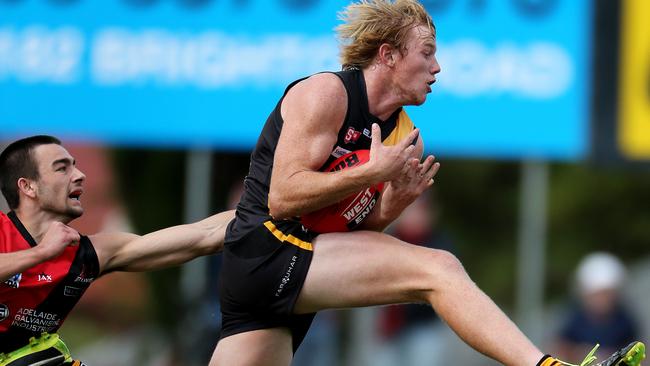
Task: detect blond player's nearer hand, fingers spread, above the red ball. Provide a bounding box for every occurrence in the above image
[367,123,420,182]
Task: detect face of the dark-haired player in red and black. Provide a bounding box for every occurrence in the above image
[33,144,86,220]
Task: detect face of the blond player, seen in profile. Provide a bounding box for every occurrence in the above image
[395,25,440,105]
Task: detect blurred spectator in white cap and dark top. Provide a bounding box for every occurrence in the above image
[558,252,639,359]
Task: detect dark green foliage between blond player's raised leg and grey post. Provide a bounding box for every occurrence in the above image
[435,160,519,305]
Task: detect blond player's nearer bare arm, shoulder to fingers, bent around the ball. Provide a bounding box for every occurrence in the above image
[269,74,417,219]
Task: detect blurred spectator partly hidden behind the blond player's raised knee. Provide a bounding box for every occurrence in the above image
[373,190,453,366]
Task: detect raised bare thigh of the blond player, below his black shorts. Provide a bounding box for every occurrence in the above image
[294,231,445,313]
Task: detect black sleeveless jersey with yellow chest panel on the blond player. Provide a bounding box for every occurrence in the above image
[226,69,414,242]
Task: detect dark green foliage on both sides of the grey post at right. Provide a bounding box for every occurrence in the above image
[428,160,650,306]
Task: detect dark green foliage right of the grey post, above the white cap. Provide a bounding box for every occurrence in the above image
[548,164,650,300]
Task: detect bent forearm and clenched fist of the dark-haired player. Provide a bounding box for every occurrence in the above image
[0,222,79,282]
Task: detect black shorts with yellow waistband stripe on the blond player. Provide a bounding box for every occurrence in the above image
[219,220,318,352]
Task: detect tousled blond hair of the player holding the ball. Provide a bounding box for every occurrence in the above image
[336,0,435,69]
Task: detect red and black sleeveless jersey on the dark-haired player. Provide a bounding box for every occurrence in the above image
[0,212,99,352]
